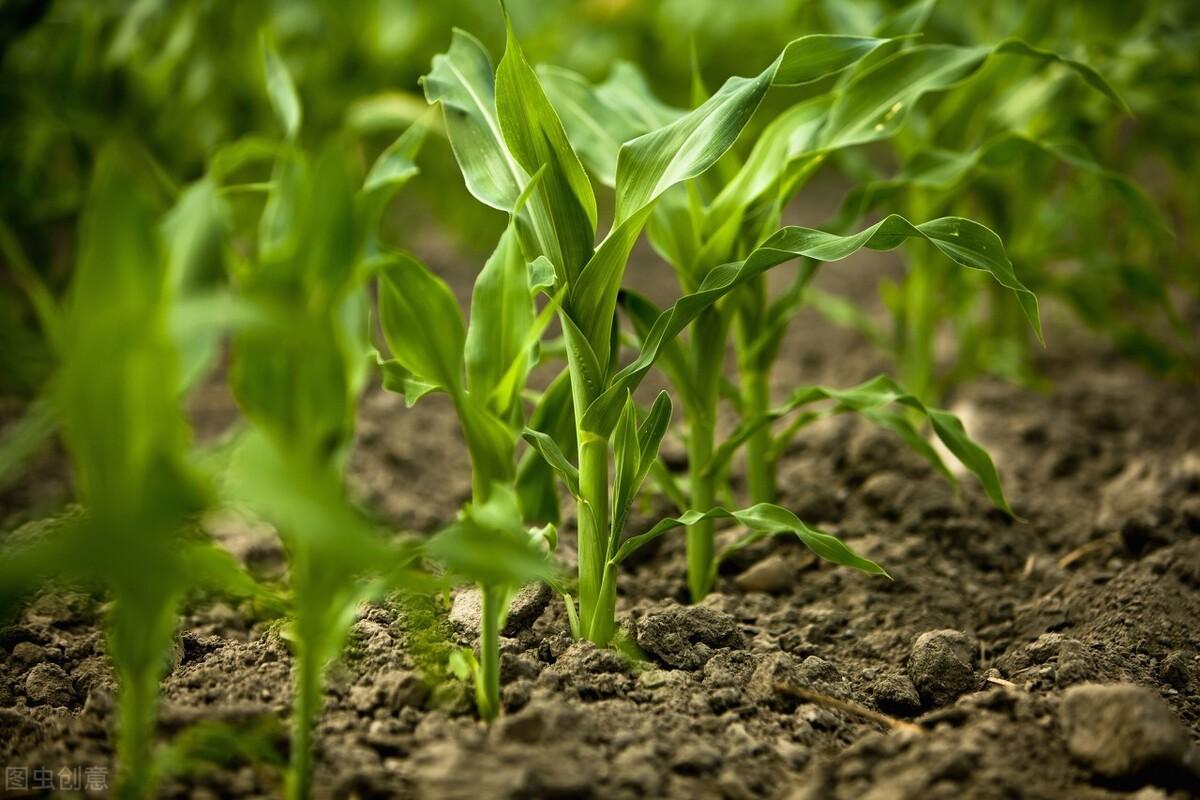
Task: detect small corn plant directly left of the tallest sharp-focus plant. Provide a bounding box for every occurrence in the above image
[372,191,562,720]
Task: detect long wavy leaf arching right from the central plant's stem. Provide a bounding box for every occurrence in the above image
[583,215,1040,435]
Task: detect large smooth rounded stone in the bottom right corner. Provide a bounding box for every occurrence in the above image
[1060,684,1200,783]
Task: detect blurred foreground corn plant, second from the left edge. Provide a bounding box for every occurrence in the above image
[224,42,438,798]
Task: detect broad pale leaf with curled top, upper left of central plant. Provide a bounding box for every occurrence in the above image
[421,28,528,211]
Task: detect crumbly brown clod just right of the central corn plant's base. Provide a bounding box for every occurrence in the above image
[636,606,745,669]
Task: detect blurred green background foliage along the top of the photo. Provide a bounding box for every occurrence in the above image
[0,0,1200,396]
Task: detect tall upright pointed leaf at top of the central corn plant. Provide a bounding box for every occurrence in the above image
[496,14,596,277]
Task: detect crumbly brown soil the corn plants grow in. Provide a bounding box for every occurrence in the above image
[0,201,1200,800]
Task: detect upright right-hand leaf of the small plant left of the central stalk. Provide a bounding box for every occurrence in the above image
[466,225,534,417]
